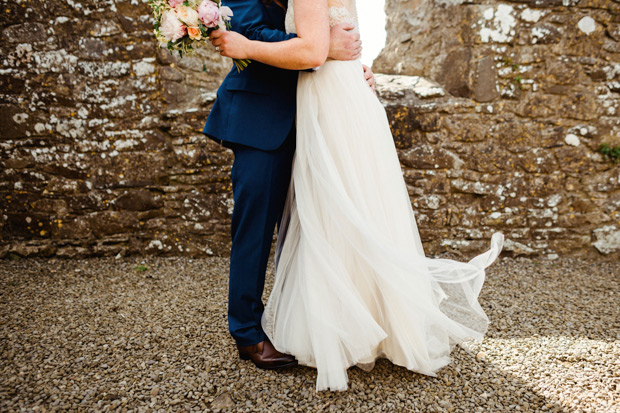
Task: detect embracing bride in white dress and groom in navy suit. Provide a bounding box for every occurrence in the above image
[203,0,503,391]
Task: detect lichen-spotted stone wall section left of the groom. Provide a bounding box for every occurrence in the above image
[0,0,232,256]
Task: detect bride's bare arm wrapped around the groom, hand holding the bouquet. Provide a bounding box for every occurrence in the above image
[211,0,330,70]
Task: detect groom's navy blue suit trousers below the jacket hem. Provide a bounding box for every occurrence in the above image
[227,127,295,346]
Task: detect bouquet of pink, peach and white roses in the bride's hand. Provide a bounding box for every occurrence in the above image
[149,0,250,71]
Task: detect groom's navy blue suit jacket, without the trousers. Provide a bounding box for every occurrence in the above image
[202,0,299,150]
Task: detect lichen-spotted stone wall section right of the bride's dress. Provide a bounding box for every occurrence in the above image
[374,0,620,257]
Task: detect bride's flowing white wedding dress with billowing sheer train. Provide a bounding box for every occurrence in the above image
[262,0,503,391]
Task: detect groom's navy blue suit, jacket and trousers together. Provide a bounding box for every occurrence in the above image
[203,0,298,346]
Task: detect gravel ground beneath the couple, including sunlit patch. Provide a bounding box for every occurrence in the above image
[0,257,620,412]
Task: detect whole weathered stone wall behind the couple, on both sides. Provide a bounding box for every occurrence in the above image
[0,0,620,257]
